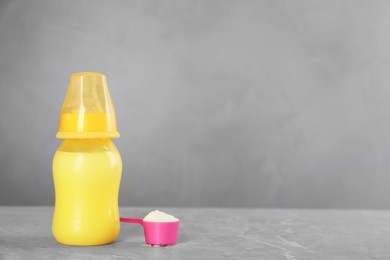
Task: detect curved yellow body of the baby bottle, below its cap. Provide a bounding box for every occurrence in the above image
[52,139,122,246]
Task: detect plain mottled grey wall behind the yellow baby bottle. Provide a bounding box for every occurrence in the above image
[0,0,390,208]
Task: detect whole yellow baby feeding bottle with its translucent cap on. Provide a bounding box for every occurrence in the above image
[52,72,122,246]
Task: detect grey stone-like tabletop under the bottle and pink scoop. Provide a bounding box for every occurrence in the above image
[0,207,390,260]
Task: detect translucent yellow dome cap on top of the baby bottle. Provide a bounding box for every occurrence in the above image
[56,72,119,139]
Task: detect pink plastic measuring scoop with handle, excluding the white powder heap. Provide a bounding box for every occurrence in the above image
[120,218,180,246]
